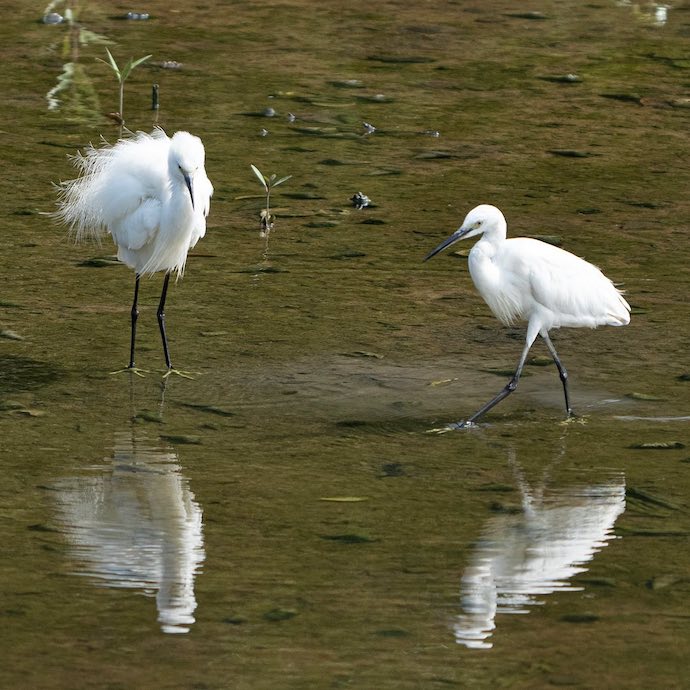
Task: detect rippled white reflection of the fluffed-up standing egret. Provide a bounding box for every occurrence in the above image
[57,430,205,633]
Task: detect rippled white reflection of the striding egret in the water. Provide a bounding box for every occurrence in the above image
[453,450,625,649]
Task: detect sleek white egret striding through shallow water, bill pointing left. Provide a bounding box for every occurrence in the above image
[424,204,630,429]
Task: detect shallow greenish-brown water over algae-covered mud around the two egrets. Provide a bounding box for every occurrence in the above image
[0,1,690,689]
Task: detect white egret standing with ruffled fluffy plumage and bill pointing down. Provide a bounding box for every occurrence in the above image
[56,129,213,376]
